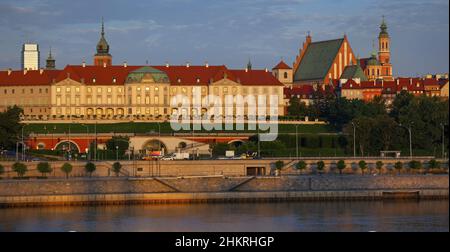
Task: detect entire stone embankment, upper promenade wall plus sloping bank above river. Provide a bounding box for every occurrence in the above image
[0,158,449,207]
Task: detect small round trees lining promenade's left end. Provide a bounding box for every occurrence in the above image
[0,162,122,179]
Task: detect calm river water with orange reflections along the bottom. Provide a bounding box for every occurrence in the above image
[0,200,449,232]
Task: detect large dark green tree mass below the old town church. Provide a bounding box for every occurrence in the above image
[288,91,449,156]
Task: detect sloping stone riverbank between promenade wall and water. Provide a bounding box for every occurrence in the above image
[0,175,449,207]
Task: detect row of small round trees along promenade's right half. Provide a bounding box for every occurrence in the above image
[275,159,441,175]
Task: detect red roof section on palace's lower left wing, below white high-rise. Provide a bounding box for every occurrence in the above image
[0,70,61,86]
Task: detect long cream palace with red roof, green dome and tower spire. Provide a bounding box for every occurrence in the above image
[0,20,284,120]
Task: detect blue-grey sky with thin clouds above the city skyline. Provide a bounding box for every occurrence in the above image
[0,0,449,76]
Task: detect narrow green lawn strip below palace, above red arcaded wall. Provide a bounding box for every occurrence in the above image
[24,122,335,134]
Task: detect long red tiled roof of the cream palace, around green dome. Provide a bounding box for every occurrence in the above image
[0,65,283,86]
